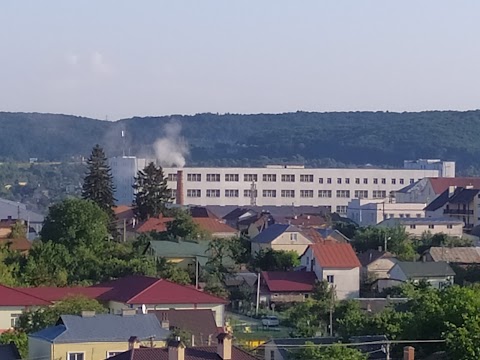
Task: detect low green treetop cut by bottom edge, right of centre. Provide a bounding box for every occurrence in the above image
[294,342,368,360]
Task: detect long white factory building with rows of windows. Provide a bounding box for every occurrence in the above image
[109,157,455,215]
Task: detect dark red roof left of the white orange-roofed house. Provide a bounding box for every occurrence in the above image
[261,271,317,292]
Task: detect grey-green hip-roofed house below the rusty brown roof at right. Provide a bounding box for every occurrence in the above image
[388,261,455,289]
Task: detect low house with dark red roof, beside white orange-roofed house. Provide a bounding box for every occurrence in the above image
[260,271,317,305]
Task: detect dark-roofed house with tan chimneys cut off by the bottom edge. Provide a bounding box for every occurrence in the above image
[111,333,258,360]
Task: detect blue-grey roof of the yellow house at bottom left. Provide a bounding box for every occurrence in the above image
[29,314,170,344]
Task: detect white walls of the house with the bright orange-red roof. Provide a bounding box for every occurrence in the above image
[300,247,360,300]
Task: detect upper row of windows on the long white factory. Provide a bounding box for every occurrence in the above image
[178,173,415,185]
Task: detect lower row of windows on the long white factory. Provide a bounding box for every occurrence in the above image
[186,189,387,199]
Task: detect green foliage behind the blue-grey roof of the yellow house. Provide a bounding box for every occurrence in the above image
[17,296,107,334]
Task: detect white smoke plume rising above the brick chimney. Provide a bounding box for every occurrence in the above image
[153,119,189,167]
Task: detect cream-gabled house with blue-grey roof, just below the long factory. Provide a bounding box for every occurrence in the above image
[252,224,314,255]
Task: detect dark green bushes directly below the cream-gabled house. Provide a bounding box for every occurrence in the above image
[252,249,300,271]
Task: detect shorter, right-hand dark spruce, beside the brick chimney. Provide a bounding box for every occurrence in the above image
[133,162,171,220]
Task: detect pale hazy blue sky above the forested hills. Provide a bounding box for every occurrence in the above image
[0,0,480,120]
